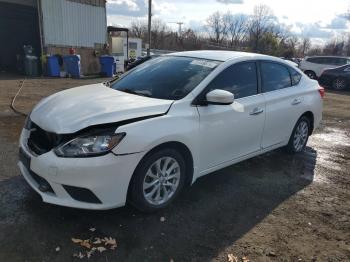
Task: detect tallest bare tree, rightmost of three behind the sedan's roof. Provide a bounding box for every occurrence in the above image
[248,5,274,52]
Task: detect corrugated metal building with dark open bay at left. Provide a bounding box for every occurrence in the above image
[0,0,107,74]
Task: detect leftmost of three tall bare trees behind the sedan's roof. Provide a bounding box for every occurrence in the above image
[206,12,228,44]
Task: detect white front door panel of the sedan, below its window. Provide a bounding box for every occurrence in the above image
[198,94,265,171]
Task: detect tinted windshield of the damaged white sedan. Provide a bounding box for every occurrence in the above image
[111,56,219,100]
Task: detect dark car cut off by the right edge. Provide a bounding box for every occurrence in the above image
[319,65,350,90]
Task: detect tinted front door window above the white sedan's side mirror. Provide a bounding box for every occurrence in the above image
[207,62,258,98]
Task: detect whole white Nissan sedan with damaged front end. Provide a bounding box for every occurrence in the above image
[18,51,324,211]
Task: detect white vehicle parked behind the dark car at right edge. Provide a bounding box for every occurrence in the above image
[299,56,350,79]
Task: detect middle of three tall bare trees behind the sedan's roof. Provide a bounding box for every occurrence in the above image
[224,12,248,49]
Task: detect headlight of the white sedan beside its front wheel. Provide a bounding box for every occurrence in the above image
[54,133,125,157]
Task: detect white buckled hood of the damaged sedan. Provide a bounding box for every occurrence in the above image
[30,84,173,134]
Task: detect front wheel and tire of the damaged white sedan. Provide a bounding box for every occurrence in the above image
[129,148,186,212]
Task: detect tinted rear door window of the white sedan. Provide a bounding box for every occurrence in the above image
[261,62,292,93]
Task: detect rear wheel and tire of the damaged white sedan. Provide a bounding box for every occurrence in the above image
[287,116,311,154]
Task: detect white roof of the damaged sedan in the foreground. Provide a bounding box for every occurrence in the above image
[167,50,274,62]
